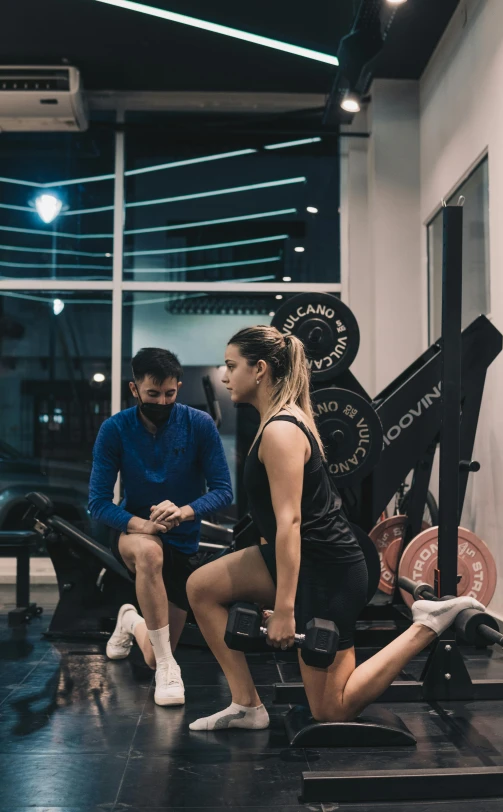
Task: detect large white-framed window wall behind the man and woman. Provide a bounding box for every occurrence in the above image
[0,114,340,529]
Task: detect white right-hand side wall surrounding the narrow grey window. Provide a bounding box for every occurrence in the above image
[420,0,503,616]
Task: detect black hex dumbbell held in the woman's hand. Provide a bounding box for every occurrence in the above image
[224,602,339,668]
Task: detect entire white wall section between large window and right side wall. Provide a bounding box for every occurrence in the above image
[341,80,425,396]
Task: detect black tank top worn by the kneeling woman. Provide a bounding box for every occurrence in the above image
[244,415,364,564]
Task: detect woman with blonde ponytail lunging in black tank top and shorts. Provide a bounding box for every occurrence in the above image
[187,326,483,730]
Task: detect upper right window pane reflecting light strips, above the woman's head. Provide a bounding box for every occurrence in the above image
[124,118,340,283]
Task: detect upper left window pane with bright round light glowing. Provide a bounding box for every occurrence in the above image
[0,130,114,281]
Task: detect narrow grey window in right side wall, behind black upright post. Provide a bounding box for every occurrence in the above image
[428,158,490,341]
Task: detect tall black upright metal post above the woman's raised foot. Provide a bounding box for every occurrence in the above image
[437,206,463,596]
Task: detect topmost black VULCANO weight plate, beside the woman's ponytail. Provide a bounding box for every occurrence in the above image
[271,292,360,382]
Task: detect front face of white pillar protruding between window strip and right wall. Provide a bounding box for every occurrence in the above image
[369,80,422,392]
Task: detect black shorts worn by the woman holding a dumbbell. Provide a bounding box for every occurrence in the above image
[259,544,368,651]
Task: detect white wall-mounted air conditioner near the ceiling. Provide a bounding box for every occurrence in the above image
[0,65,88,132]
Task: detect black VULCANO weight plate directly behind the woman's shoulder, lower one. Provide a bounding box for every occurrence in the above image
[311,388,383,488]
